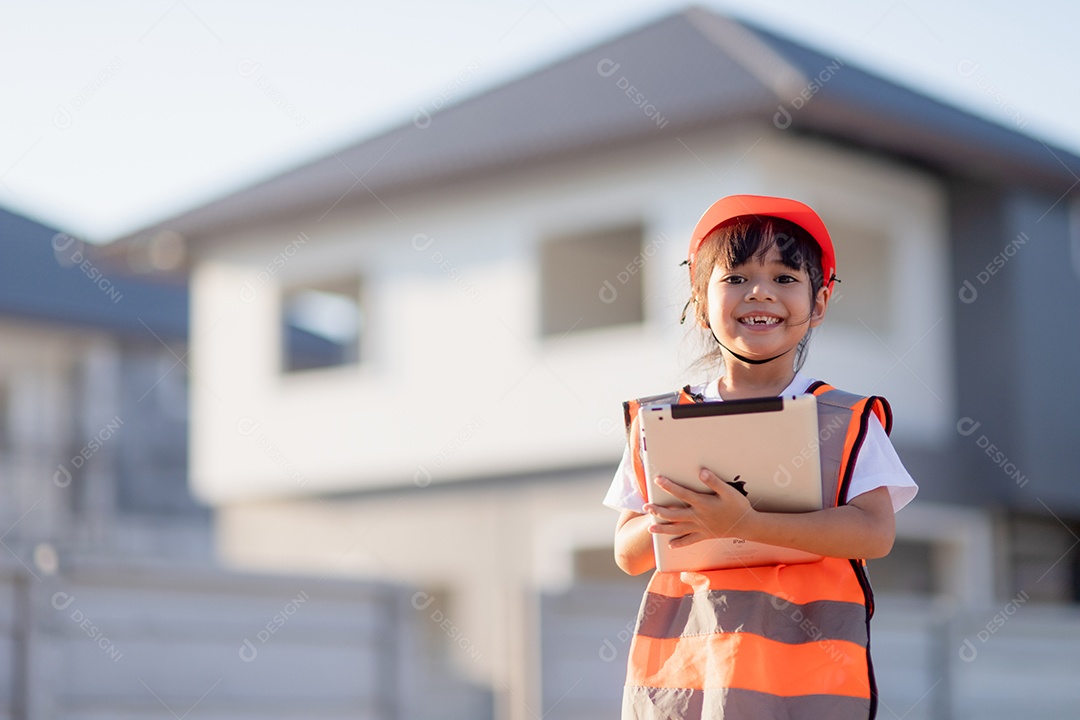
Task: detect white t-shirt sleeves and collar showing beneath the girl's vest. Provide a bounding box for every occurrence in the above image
[604,373,919,513]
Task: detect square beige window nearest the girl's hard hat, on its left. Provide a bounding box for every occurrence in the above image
[540,226,647,335]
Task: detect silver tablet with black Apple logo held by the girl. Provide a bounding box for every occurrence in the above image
[638,395,823,572]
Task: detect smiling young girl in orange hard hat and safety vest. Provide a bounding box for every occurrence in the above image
[604,195,917,720]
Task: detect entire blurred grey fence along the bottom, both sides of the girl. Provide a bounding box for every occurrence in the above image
[8,565,1080,720]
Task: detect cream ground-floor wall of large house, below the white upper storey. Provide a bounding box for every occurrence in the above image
[216,473,618,690]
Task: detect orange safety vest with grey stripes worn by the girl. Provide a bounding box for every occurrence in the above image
[622,382,892,720]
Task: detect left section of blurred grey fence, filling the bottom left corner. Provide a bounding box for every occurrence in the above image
[0,566,489,720]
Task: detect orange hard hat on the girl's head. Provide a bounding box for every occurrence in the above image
[688,195,836,287]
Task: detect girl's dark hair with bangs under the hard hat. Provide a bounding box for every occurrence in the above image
[690,216,825,371]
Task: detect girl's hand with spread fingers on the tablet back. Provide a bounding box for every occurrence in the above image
[645,468,755,547]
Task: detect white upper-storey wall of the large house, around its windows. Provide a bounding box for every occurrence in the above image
[191,128,954,502]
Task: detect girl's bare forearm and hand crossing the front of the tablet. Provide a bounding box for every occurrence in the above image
[643,470,896,567]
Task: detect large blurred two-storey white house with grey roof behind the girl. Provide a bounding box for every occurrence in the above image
[113,10,1080,718]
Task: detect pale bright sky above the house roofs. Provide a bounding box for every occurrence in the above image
[0,0,1080,242]
